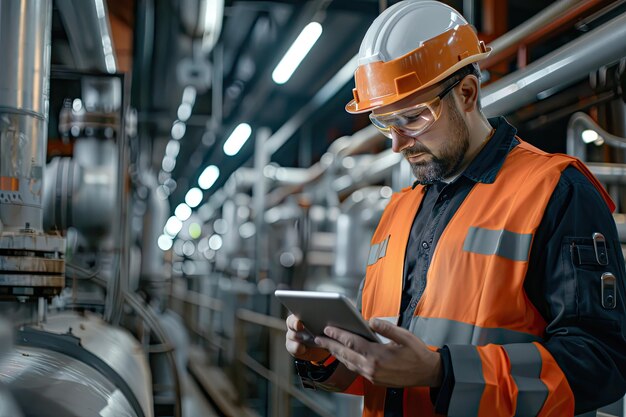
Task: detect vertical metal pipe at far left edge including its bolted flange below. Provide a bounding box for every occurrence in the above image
[0,0,65,300]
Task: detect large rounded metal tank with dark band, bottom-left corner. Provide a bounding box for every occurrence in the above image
[0,312,153,417]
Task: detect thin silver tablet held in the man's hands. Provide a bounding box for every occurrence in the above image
[274,290,381,343]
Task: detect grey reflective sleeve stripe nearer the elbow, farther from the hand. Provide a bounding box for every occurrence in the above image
[502,343,548,417]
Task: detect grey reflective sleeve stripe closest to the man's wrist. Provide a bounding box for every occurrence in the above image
[448,345,485,417]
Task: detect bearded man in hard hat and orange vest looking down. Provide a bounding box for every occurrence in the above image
[286,0,626,416]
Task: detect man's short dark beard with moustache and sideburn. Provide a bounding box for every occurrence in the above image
[402,100,469,184]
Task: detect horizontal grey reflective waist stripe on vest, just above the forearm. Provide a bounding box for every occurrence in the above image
[409,316,541,347]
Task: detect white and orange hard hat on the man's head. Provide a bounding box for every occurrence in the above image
[346,0,491,113]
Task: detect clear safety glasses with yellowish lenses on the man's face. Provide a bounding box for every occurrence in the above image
[370,78,463,138]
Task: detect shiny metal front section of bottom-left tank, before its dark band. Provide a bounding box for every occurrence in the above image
[0,347,136,417]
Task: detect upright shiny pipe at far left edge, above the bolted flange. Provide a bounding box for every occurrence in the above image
[0,0,52,232]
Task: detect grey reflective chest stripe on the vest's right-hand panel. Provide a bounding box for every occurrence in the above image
[463,227,533,261]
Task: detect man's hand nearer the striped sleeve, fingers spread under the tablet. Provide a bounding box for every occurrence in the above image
[315,319,442,387]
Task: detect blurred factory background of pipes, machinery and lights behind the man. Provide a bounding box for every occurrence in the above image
[0,0,626,417]
